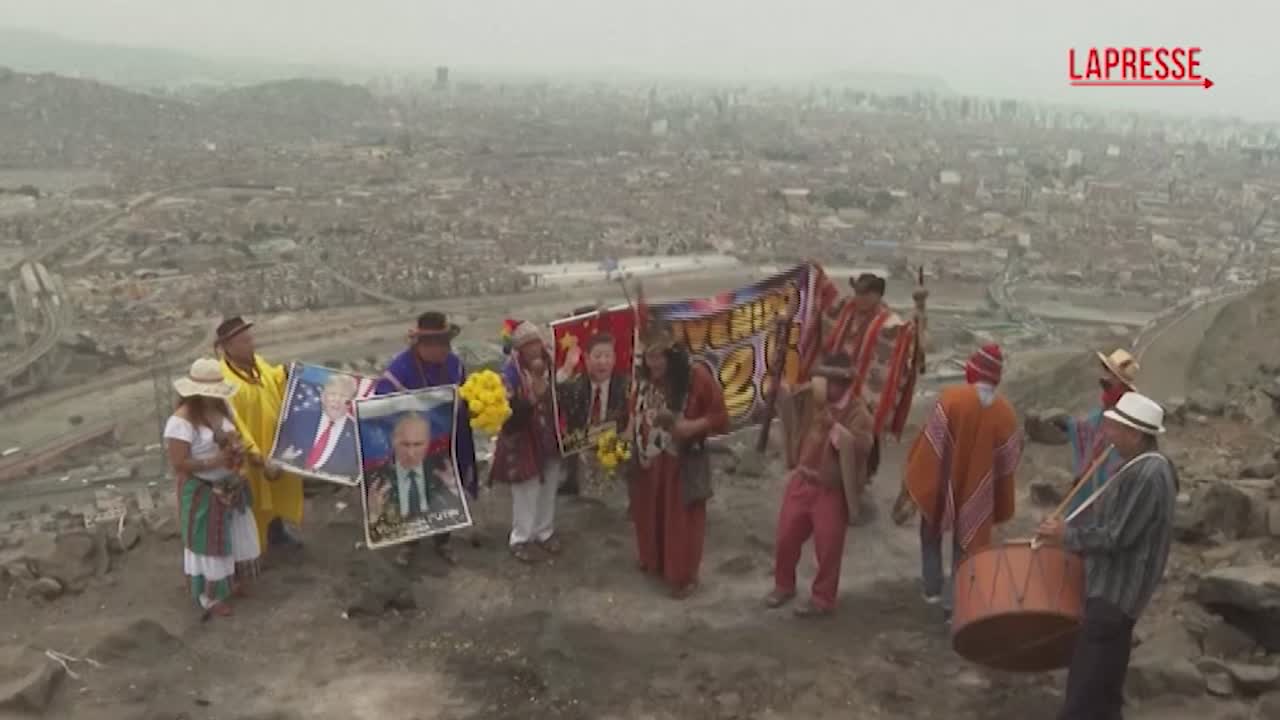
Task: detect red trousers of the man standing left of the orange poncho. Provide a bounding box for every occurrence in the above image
[773,473,849,610]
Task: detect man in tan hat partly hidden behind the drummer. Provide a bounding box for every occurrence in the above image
[1052,348,1139,514]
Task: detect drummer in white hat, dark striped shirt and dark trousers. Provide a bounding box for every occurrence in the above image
[1037,392,1178,720]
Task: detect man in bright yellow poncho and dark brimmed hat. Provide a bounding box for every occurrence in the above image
[214,315,303,547]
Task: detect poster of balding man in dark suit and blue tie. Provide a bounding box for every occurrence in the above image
[356,386,471,548]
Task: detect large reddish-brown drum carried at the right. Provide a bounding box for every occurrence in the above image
[951,541,1084,673]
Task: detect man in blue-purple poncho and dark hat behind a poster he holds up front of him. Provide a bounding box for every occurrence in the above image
[374,310,480,565]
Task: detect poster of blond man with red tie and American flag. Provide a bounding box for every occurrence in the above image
[271,363,375,486]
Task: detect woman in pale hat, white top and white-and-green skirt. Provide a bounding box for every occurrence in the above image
[164,357,261,619]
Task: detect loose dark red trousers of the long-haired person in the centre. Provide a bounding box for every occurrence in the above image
[631,456,707,589]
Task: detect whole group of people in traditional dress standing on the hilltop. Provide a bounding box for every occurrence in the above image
[164,269,1178,720]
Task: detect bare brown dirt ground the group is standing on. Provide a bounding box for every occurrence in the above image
[0,275,1239,720]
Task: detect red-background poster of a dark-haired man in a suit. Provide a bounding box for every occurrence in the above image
[552,305,635,455]
